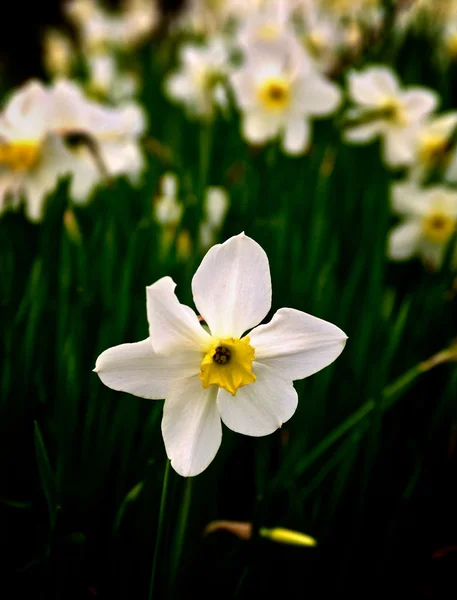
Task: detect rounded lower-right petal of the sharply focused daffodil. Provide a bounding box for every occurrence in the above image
[217,363,298,437]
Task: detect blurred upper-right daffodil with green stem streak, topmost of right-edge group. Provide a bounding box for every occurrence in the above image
[344,66,439,167]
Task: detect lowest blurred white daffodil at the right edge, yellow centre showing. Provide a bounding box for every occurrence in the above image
[388,182,457,269]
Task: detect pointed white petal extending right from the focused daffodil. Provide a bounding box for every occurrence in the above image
[249,308,347,380]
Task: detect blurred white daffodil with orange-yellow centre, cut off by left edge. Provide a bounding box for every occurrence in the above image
[0,81,69,221]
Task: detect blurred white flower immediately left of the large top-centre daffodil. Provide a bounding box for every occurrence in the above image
[165,38,230,118]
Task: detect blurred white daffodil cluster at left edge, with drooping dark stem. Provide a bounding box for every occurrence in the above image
[0,80,145,221]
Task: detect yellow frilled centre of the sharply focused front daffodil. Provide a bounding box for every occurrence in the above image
[199,336,256,396]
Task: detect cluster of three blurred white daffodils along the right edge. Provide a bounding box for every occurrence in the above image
[344,66,457,269]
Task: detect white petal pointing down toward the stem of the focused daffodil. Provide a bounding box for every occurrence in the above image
[162,377,222,477]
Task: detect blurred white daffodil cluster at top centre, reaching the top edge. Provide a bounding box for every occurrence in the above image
[165,2,350,155]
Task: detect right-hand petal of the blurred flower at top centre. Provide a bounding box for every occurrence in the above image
[297,75,341,116]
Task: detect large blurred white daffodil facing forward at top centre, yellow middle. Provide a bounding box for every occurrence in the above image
[231,52,341,155]
